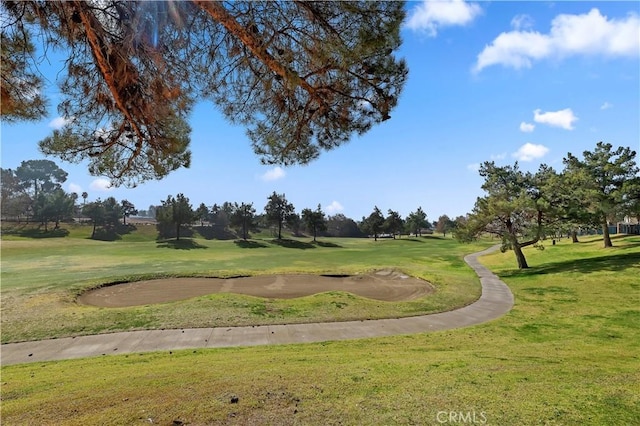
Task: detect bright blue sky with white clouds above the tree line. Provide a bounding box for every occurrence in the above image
[1,1,640,220]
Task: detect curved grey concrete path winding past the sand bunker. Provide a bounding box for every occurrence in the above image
[0,246,513,365]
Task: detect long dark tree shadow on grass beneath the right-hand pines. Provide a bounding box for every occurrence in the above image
[500,253,640,277]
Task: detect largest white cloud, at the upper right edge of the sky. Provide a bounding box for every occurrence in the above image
[473,9,640,72]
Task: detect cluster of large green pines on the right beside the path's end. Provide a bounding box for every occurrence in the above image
[455,142,640,269]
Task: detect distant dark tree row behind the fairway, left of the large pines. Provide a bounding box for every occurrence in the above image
[0,160,464,241]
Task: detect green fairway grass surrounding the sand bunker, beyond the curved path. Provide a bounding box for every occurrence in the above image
[2,227,487,343]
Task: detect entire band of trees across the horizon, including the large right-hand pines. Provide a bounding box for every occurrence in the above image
[6,142,640,256]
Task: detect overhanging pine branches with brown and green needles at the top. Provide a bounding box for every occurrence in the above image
[2,0,408,186]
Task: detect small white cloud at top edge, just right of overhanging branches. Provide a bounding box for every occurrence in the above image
[406,0,482,37]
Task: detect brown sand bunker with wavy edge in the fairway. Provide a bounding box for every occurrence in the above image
[78,270,433,308]
